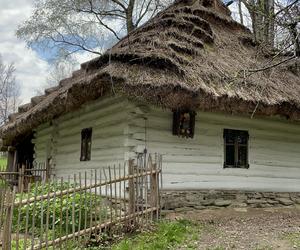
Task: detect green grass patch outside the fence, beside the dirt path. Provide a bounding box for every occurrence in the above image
[111,220,200,250]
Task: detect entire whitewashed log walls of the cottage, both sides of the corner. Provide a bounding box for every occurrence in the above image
[34,97,300,192]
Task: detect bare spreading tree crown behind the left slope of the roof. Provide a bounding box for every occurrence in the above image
[17,0,172,59]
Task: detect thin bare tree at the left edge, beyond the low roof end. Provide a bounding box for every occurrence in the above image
[0,55,20,124]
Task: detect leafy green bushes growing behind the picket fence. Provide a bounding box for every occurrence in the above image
[13,183,105,236]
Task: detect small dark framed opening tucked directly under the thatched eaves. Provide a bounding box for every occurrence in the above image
[173,110,196,138]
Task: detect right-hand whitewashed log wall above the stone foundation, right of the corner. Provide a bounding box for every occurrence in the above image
[130,104,300,192]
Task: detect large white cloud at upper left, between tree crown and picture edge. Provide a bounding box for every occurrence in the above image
[0,0,50,103]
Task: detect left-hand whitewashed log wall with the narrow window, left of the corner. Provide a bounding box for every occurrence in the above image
[33,94,129,178]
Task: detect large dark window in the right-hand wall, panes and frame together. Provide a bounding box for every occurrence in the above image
[224,129,249,168]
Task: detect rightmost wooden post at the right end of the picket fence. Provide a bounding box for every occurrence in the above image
[150,163,159,219]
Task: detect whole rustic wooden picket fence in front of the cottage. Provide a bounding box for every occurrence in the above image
[0,155,161,250]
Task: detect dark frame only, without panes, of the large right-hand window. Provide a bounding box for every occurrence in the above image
[223,129,250,169]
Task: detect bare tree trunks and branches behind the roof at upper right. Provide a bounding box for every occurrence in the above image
[230,0,300,55]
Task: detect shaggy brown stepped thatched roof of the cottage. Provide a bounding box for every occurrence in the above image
[0,0,300,145]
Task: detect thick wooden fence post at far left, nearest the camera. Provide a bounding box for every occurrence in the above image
[2,188,15,250]
